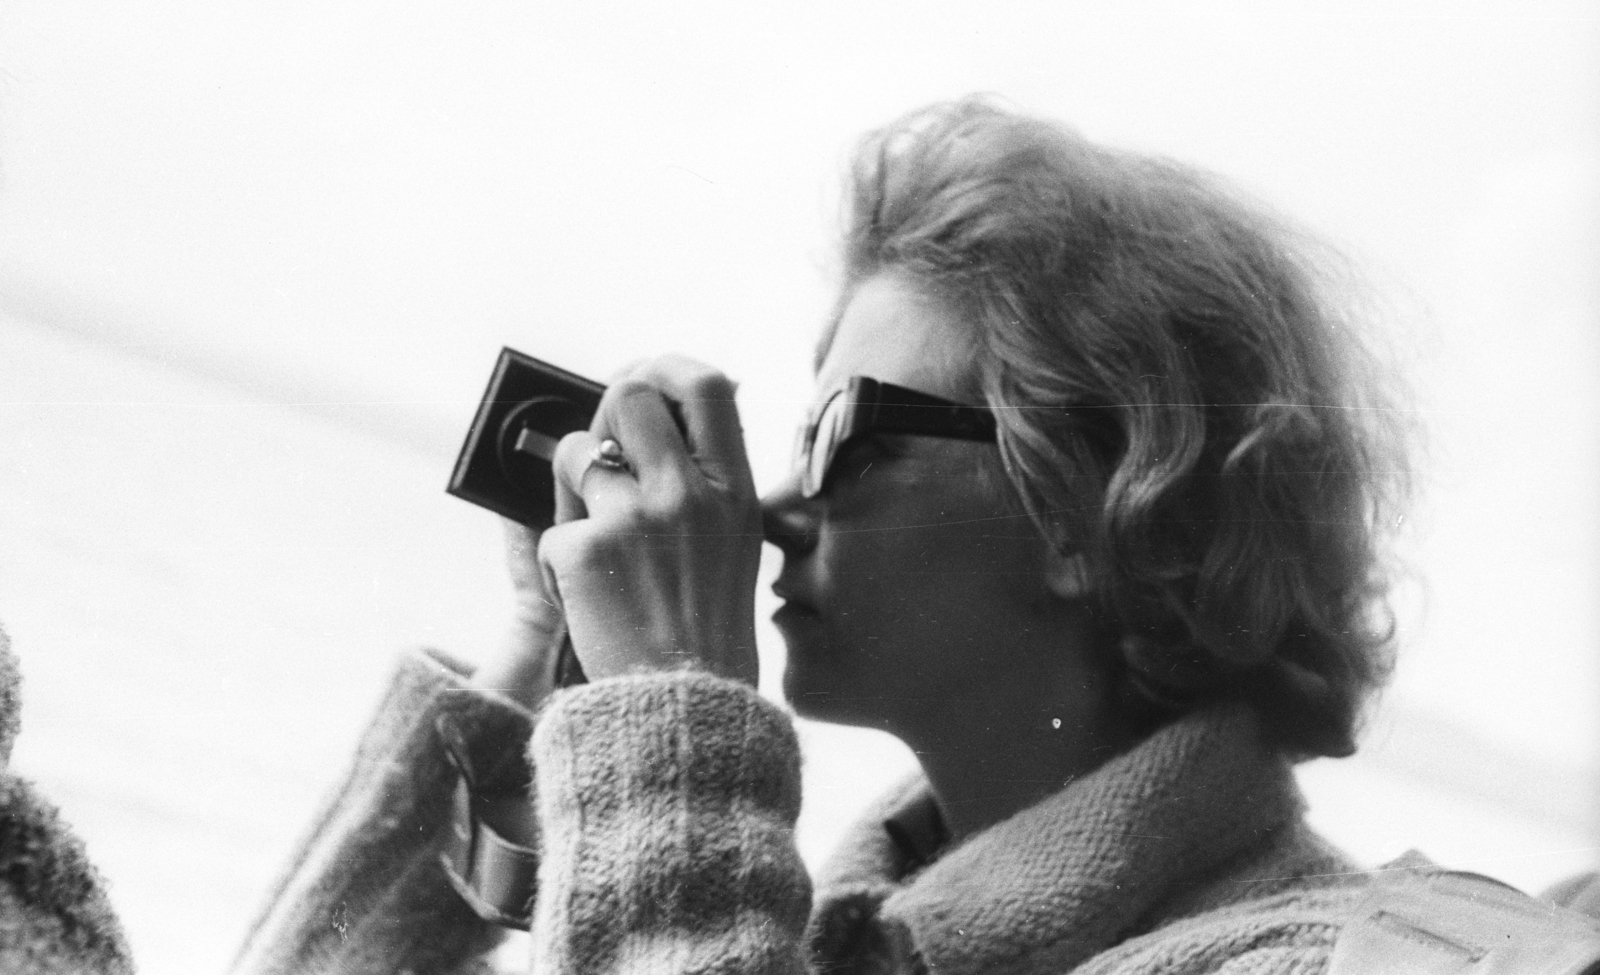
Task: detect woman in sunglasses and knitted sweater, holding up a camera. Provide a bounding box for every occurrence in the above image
[232,101,1400,973]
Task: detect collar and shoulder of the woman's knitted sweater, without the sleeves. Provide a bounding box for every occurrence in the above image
[811,708,1363,975]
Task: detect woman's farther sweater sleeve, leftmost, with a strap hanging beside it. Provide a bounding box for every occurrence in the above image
[234,652,533,975]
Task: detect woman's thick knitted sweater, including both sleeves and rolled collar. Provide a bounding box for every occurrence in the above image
[237,646,1365,975]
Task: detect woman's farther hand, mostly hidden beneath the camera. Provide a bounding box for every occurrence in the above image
[472,520,566,709]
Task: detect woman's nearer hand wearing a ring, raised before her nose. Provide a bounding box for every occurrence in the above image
[539,357,762,685]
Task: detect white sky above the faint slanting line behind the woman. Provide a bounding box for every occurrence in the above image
[0,0,1600,966]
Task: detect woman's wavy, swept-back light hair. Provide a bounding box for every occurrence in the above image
[842,98,1406,757]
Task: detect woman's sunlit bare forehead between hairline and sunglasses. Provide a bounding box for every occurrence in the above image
[816,272,973,400]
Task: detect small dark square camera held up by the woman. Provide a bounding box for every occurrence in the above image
[446,349,605,532]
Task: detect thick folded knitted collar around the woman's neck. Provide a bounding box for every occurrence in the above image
[818,706,1301,975]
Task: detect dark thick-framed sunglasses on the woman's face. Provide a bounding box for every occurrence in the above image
[794,376,995,498]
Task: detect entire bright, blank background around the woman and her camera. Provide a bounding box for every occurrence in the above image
[0,0,1600,970]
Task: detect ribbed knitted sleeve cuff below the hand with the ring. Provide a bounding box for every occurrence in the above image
[531,672,811,975]
